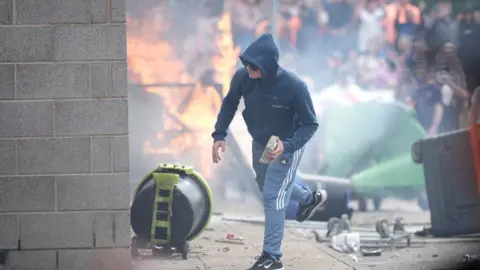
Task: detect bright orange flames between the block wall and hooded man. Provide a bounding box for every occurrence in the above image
[127,13,239,177]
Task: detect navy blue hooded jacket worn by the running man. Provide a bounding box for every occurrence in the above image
[212,34,318,153]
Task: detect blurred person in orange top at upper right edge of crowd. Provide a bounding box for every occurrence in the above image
[384,0,421,48]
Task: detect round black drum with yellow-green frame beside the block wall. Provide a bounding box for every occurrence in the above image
[130,164,213,259]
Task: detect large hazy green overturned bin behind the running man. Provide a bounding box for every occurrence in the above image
[320,101,426,211]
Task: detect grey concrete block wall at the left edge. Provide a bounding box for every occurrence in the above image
[0,0,132,270]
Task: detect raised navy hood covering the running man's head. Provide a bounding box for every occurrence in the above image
[240,34,279,82]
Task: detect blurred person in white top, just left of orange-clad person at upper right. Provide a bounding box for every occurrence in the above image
[357,0,384,53]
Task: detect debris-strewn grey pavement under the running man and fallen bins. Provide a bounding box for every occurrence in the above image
[130,199,480,270]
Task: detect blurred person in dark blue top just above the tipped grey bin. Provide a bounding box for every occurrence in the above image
[409,71,443,136]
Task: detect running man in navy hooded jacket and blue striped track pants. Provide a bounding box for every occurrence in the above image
[212,34,327,270]
